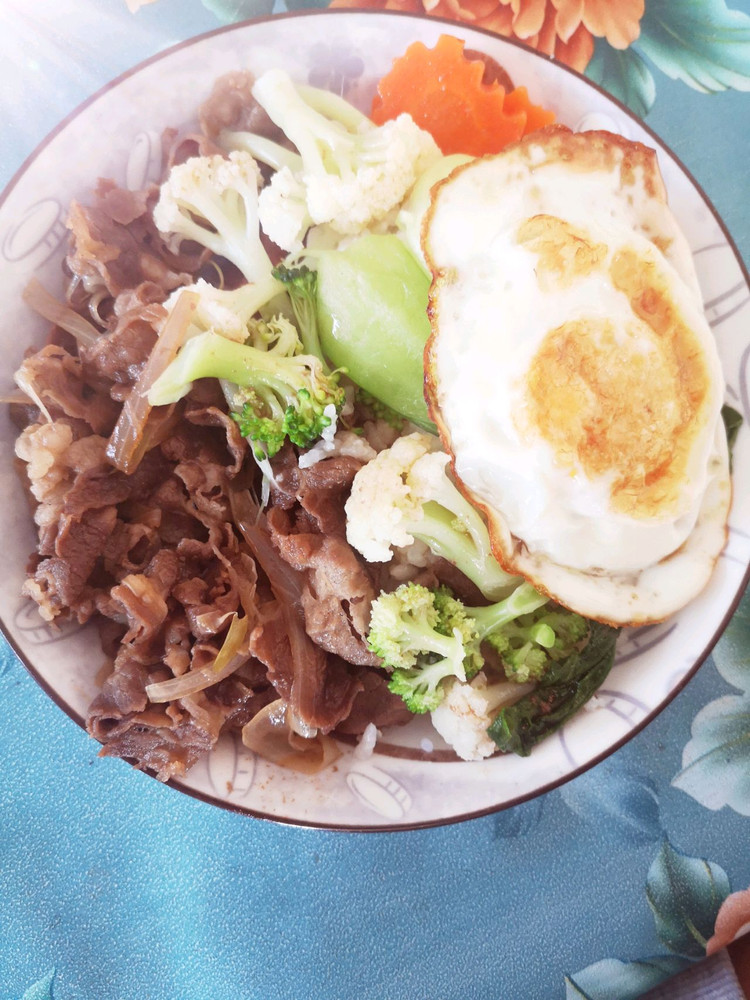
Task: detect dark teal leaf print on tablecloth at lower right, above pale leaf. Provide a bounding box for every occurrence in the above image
[646,839,729,958]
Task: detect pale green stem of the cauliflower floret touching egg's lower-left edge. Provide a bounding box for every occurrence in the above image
[408,500,533,600]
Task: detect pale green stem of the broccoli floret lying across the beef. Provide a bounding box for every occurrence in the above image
[148,333,320,406]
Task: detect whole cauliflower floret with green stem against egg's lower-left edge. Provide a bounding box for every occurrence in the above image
[346,433,519,600]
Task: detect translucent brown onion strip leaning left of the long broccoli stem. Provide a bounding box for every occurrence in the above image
[107,292,198,474]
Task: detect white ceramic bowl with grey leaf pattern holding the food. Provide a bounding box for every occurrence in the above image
[0,11,750,830]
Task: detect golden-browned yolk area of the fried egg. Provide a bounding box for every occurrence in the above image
[523,232,710,518]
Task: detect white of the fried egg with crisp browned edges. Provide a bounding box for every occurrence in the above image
[424,132,731,624]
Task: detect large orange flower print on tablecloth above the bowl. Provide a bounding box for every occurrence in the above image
[331,0,644,72]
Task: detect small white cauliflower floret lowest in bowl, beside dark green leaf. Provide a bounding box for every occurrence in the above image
[430,673,534,760]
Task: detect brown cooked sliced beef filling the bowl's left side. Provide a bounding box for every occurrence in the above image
[15,74,424,780]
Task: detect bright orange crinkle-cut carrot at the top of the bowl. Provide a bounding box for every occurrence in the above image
[371,35,555,156]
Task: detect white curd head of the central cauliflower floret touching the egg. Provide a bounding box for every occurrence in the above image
[345,432,447,562]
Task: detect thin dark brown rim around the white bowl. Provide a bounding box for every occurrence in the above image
[0,8,750,834]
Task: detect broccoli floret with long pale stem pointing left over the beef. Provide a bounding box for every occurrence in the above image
[148,324,344,457]
